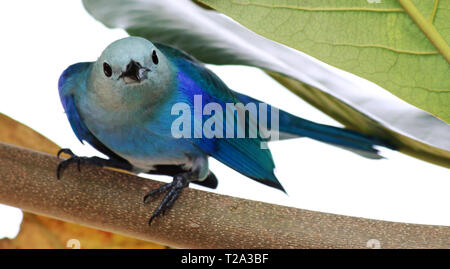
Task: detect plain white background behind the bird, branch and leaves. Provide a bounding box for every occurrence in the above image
[0,0,450,238]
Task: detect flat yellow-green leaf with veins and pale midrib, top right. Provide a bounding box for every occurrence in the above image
[199,0,450,123]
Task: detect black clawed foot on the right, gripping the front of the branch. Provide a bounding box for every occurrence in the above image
[144,174,189,225]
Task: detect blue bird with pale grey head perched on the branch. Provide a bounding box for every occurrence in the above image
[57,36,394,225]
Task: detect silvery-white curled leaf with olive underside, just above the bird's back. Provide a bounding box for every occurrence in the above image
[83,0,450,167]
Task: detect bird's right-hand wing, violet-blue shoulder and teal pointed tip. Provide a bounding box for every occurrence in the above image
[155,44,284,191]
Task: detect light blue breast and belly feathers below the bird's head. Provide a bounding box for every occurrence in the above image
[81,91,203,169]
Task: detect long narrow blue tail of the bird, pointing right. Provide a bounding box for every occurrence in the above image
[232,93,395,159]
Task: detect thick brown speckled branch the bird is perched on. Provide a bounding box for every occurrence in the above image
[0,143,450,248]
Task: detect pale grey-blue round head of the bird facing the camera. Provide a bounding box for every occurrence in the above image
[90,37,171,110]
